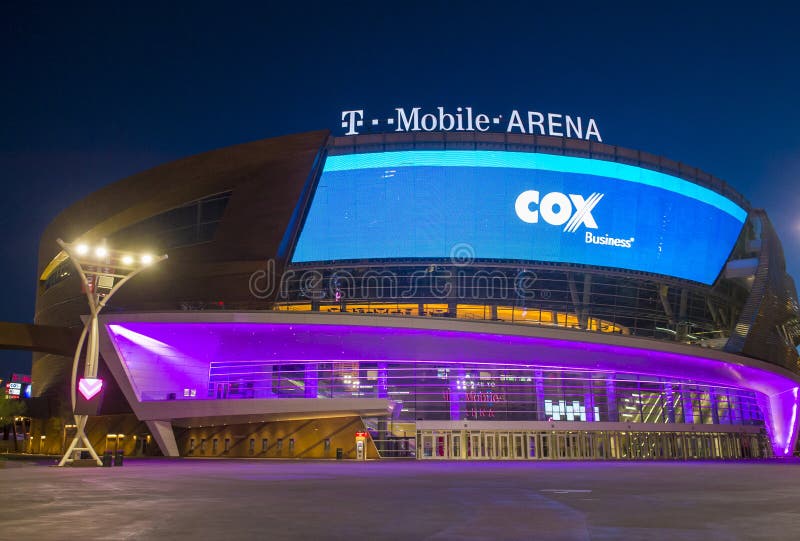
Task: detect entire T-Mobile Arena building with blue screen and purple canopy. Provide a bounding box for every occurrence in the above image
[23,127,800,460]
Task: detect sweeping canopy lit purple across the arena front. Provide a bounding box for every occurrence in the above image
[101,312,800,456]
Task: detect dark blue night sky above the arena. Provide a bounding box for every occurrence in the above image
[0,1,800,378]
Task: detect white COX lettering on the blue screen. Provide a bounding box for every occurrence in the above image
[514,190,604,233]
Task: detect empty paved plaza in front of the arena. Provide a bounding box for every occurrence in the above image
[0,459,800,540]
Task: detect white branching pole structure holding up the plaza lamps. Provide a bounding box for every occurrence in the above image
[56,239,167,466]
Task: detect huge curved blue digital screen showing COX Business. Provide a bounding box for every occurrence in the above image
[292,150,747,284]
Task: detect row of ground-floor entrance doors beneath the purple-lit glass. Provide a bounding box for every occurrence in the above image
[417,427,771,460]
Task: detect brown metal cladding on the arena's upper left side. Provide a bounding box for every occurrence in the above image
[32,131,329,410]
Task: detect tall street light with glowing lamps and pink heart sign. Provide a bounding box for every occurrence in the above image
[56,239,167,466]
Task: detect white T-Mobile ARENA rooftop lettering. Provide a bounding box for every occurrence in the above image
[342,107,603,142]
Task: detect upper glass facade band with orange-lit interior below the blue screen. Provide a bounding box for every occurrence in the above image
[274,263,745,349]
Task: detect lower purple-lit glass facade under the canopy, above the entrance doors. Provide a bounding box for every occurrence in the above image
[203,361,764,426]
